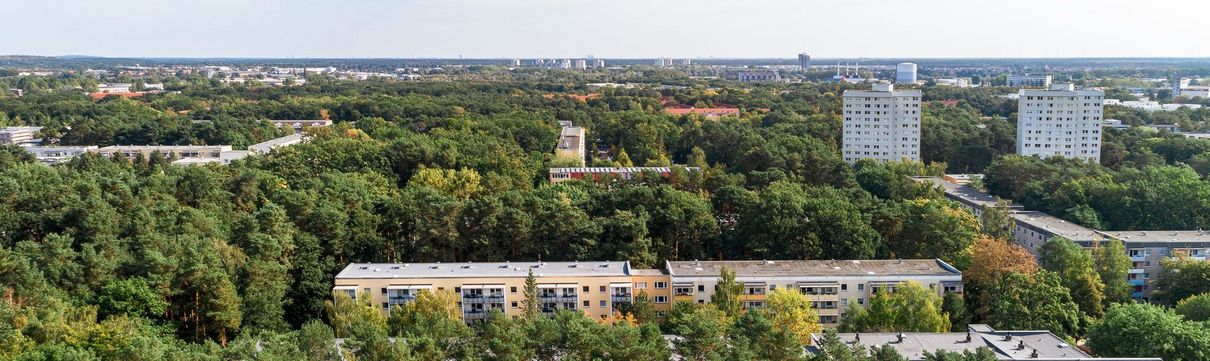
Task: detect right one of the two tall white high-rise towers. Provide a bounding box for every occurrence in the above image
[1016,84,1105,162]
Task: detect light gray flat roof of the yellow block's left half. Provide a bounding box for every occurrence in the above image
[336,260,630,280]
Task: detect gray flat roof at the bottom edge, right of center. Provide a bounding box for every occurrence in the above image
[812,325,1159,361]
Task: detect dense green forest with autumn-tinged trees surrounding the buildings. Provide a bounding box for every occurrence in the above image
[0,69,1210,360]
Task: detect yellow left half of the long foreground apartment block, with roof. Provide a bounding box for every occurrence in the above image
[333,262,655,321]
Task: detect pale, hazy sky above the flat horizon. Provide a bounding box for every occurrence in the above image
[0,0,1210,58]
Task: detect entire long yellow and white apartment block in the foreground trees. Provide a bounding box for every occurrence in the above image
[333,259,962,326]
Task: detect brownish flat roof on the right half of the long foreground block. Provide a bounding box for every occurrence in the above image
[667,259,962,277]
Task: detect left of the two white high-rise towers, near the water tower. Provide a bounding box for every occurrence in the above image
[841,84,921,164]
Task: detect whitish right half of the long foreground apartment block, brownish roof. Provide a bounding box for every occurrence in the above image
[666,259,962,327]
